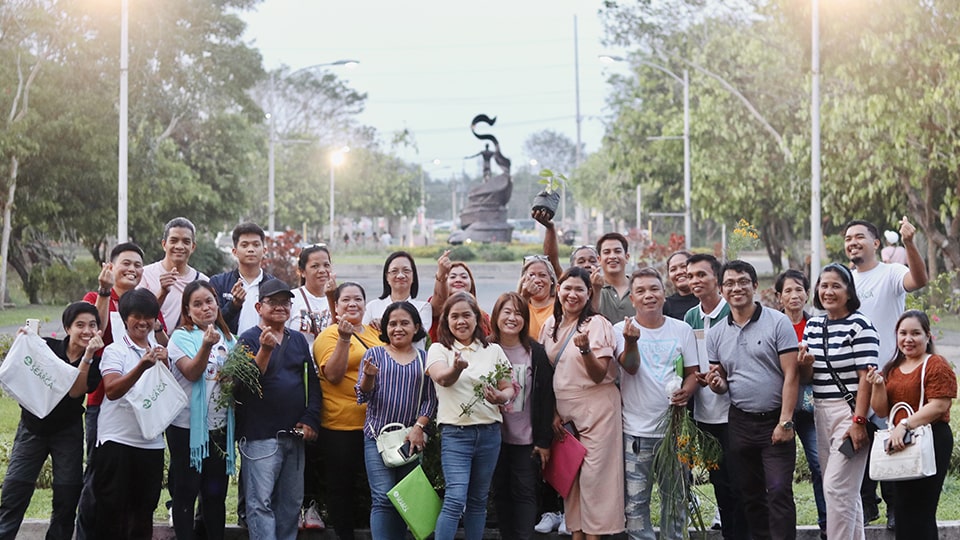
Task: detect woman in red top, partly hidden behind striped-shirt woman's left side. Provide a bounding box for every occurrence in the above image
[773,269,827,538]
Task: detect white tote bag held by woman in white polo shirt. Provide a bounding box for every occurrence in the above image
[123,362,187,439]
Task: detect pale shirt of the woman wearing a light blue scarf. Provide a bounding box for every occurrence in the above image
[167,328,237,430]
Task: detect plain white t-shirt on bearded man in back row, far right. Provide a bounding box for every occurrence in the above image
[853,263,910,370]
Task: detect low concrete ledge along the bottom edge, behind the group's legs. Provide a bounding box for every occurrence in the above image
[17,519,960,540]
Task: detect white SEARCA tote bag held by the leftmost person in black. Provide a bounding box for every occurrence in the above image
[0,331,80,418]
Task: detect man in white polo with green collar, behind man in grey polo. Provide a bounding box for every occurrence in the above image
[683,253,747,540]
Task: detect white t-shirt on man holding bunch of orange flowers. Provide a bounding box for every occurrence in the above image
[613,317,700,438]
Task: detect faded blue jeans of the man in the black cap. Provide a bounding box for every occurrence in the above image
[240,435,304,540]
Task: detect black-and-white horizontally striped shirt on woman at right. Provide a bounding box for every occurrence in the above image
[803,311,880,399]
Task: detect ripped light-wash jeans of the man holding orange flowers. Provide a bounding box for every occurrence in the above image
[623,433,687,540]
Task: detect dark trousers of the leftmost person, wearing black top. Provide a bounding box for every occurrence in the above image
[0,418,83,539]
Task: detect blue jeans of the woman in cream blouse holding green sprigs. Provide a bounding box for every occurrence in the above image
[434,422,500,540]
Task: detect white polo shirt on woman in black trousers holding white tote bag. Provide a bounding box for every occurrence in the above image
[97,333,167,450]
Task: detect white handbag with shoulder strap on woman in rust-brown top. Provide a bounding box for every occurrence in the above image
[870,357,937,481]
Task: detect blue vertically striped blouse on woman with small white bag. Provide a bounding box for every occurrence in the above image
[354,346,437,439]
